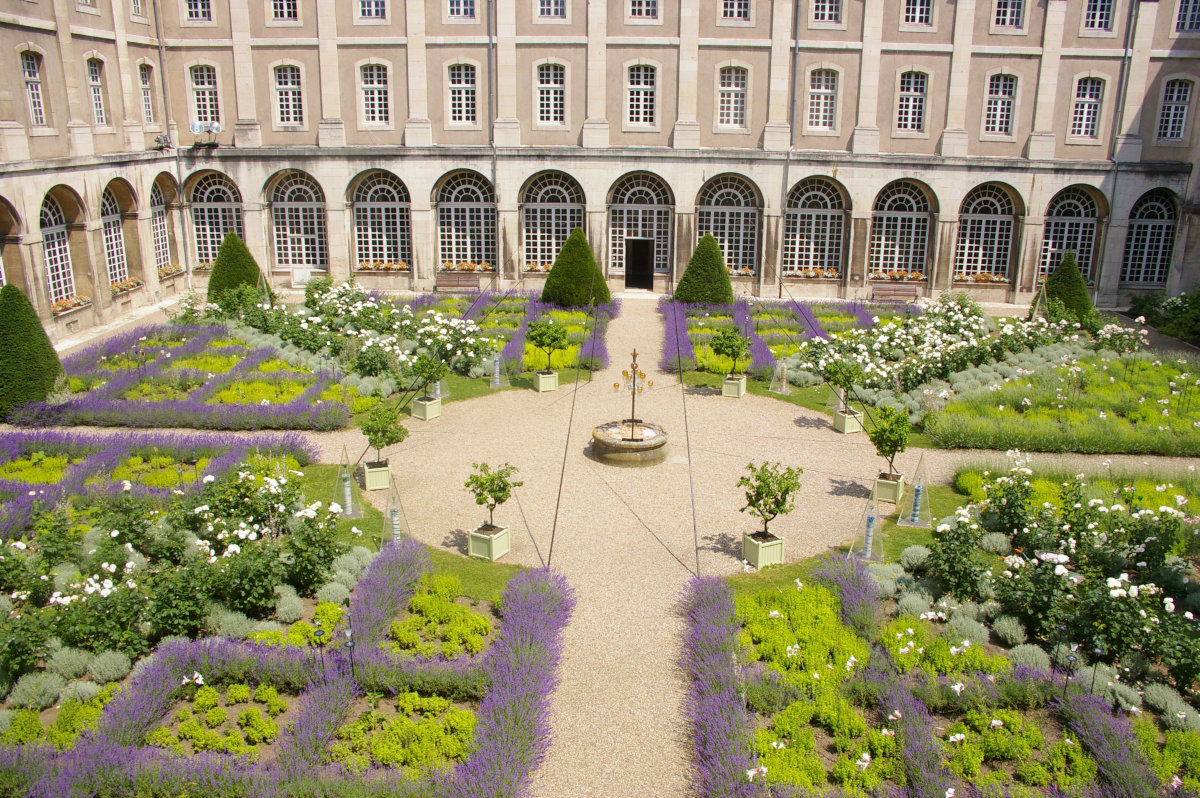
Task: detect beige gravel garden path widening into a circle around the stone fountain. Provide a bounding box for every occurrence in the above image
[30,294,1200,798]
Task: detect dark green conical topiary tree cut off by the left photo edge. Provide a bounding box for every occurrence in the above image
[0,286,62,419]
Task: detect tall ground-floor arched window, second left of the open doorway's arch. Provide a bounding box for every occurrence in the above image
[437,170,497,269]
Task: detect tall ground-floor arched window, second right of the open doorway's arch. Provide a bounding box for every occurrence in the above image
[784,178,846,277]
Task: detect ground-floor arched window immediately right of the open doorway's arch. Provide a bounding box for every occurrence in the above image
[696,174,762,275]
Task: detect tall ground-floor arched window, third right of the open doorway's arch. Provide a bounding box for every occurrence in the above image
[869,180,932,277]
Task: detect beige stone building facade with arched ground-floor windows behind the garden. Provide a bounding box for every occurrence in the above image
[0,0,1200,334]
